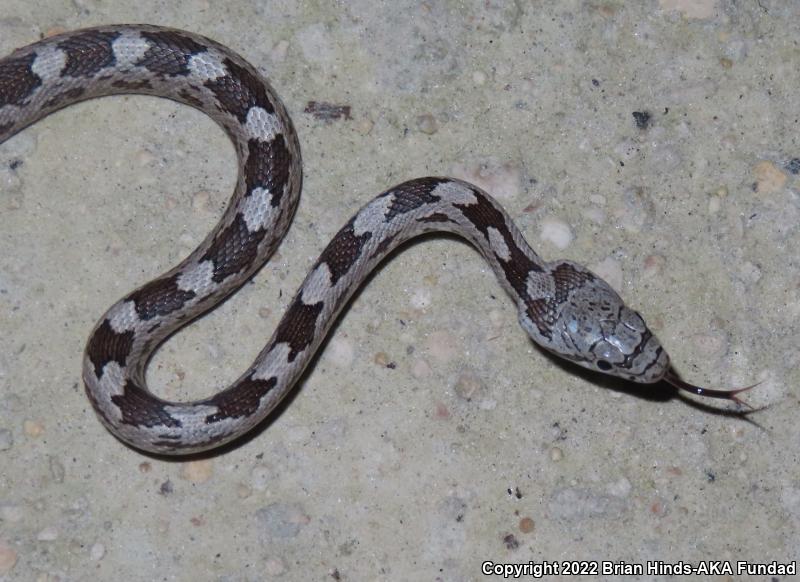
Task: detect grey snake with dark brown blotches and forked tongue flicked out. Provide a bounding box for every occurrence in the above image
[0,24,750,455]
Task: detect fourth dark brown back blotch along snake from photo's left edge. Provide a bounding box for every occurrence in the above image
[204,58,275,123]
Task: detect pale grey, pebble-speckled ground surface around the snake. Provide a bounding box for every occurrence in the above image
[0,0,800,582]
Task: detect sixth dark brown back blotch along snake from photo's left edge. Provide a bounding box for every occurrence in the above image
[201,214,267,283]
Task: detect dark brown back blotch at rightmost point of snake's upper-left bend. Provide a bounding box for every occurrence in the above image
[244,135,292,208]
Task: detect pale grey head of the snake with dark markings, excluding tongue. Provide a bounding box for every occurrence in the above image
[520,261,670,384]
